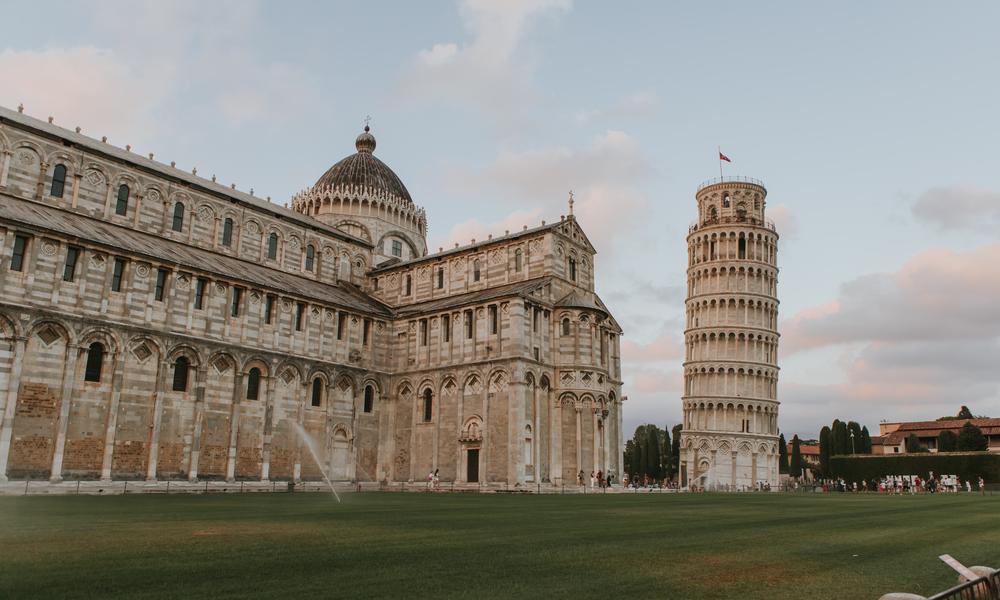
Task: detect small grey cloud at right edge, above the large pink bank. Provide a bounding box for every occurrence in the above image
[912,186,1000,236]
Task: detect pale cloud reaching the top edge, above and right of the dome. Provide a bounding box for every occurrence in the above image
[397,0,572,121]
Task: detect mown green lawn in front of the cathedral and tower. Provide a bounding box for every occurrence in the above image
[0,493,1000,600]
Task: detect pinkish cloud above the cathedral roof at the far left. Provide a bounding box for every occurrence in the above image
[0,46,164,145]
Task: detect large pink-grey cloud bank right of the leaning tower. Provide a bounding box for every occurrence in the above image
[779,243,1000,436]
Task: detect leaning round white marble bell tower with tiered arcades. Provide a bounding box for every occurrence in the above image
[681,177,778,489]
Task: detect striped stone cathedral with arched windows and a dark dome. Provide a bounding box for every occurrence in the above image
[0,108,623,488]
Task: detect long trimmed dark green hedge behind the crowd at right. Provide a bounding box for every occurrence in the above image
[830,452,1000,484]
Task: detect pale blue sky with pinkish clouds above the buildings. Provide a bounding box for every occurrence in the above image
[0,0,1000,439]
